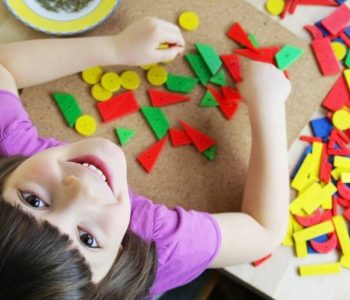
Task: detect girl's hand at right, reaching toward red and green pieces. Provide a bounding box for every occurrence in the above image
[238,61,291,107]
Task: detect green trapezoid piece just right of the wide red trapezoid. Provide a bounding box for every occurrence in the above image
[141,106,170,140]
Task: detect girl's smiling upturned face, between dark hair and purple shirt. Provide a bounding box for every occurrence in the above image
[3,138,131,283]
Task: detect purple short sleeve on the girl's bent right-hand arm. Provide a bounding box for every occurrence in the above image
[151,205,221,296]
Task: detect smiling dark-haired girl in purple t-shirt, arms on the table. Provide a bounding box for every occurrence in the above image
[0,18,290,299]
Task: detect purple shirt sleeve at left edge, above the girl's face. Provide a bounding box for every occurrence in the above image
[0,90,65,156]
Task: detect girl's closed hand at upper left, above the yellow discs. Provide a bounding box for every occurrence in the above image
[115,17,185,66]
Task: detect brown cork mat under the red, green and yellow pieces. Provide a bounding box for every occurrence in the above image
[16,0,335,213]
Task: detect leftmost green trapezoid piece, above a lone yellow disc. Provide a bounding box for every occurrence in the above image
[52,93,82,127]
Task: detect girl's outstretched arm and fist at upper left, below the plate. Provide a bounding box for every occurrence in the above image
[0,17,185,89]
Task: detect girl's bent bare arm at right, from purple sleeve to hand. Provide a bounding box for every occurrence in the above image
[210,62,291,268]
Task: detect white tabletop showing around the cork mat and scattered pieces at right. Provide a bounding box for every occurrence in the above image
[224,0,350,300]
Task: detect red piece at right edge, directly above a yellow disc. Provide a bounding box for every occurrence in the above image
[322,75,350,111]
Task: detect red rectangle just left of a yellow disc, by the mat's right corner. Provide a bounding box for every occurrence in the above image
[311,37,342,76]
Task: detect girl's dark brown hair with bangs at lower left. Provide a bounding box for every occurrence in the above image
[0,156,157,300]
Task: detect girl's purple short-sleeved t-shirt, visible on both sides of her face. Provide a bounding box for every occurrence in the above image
[0,90,221,297]
